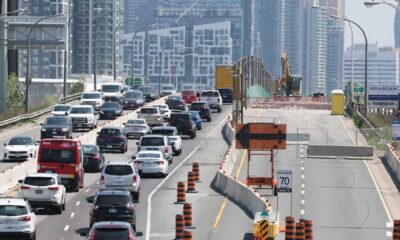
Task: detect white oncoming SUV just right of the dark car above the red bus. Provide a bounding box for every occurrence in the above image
[69,105,97,131]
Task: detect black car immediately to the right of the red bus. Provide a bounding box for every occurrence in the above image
[82,144,105,172]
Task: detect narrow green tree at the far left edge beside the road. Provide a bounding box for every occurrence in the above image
[7,73,25,113]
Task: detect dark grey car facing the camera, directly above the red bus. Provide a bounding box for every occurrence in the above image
[40,116,72,139]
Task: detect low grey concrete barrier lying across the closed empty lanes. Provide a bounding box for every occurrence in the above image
[307,145,374,158]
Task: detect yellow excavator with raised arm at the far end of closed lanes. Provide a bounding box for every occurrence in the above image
[274,51,302,96]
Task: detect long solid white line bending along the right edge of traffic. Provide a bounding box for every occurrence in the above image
[145,113,228,240]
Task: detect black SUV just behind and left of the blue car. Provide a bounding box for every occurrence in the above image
[169,113,196,139]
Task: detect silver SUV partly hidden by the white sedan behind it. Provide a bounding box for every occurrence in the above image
[136,135,173,163]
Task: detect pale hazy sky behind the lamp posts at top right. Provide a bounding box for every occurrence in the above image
[345,0,396,48]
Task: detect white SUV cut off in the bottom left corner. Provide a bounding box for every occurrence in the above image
[0,198,36,240]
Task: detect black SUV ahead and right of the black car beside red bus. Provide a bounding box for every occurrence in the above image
[96,127,128,153]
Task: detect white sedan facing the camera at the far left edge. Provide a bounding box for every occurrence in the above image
[3,136,38,162]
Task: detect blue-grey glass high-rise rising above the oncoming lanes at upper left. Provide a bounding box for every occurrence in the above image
[72,0,123,75]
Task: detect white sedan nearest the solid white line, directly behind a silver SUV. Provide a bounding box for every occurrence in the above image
[133,151,169,177]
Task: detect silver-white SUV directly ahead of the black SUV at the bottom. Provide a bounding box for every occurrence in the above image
[100,161,140,202]
